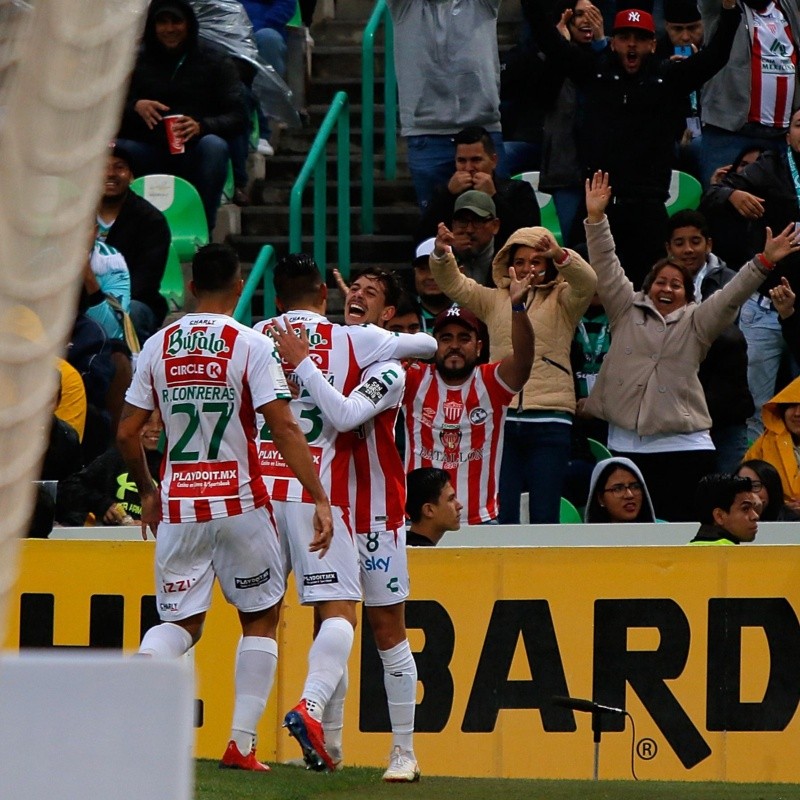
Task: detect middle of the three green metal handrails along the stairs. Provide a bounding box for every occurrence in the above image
[289,92,350,278]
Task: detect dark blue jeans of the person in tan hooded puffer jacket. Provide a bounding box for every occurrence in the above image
[498,420,572,525]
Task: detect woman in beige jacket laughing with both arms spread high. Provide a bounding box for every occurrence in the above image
[585,172,800,522]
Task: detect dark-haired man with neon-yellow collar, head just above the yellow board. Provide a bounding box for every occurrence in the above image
[689,473,761,545]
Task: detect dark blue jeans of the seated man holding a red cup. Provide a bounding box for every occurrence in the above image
[117,133,229,238]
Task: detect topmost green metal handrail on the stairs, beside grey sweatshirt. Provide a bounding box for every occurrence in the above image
[361,0,397,234]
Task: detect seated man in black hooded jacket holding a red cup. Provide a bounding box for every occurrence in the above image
[117,0,247,233]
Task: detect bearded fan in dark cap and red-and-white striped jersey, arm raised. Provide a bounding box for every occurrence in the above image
[403,284,533,525]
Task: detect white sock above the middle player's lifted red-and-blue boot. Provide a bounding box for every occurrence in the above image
[302,617,354,721]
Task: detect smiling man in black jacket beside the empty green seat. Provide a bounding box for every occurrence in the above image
[97,144,172,344]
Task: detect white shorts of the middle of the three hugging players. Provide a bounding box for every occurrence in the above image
[272,500,361,605]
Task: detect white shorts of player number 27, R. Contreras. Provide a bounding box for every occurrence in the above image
[156,508,286,622]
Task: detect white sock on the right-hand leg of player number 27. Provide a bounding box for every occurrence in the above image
[231,636,278,755]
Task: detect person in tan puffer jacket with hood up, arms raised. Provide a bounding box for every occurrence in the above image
[430,223,597,524]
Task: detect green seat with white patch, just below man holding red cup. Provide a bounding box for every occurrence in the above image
[131,175,208,262]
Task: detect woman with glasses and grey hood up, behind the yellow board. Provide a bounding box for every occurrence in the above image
[583,458,657,522]
